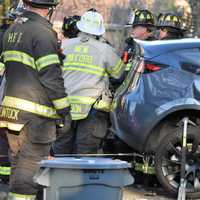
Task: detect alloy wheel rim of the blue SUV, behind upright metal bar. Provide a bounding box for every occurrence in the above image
[161,138,200,192]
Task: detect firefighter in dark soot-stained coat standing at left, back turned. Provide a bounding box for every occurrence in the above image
[0,0,70,200]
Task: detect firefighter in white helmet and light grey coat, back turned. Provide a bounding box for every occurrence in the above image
[53,11,124,154]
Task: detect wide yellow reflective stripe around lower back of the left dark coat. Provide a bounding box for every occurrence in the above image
[2,96,59,118]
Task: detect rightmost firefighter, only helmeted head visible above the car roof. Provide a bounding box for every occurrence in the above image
[157,13,185,40]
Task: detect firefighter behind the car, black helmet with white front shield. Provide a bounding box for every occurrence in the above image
[122,9,156,72]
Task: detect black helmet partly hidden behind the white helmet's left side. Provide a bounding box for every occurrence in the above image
[62,15,81,38]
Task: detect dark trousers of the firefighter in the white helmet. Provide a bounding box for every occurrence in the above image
[52,111,108,154]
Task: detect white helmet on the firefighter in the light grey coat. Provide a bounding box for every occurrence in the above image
[76,11,105,36]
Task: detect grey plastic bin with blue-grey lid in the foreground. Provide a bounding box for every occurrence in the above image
[34,157,134,200]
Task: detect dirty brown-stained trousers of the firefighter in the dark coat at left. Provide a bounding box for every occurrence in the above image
[7,128,51,195]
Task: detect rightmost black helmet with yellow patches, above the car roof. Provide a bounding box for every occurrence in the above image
[157,13,184,31]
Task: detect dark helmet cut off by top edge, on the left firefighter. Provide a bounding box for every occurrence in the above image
[23,0,58,8]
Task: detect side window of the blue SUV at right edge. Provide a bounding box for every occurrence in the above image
[175,48,200,75]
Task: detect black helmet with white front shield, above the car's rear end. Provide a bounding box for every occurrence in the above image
[127,9,155,27]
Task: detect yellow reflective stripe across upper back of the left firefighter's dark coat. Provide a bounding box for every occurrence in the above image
[3,51,36,69]
